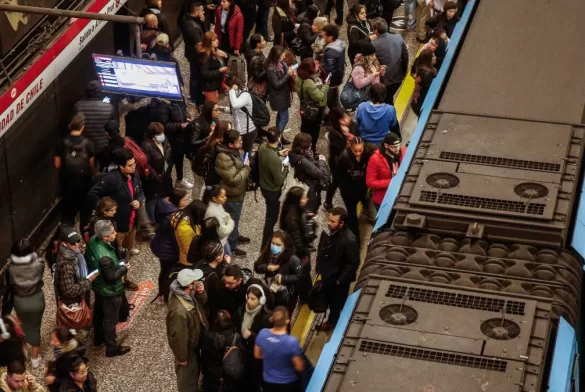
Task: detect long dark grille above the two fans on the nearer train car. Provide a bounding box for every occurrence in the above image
[386,285,525,316]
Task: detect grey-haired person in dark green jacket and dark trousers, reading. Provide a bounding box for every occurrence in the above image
[87,220,130,357]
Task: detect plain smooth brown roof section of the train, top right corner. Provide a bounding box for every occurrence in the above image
[439,0,585,124]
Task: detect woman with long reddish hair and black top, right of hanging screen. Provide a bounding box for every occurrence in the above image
[196,32,229,103]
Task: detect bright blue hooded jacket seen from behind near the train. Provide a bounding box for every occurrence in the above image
[355,101,399,144]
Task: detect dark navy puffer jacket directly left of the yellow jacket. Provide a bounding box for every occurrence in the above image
[150,199,179,262]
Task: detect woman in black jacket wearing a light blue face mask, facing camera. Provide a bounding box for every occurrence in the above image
[254,230,302,310]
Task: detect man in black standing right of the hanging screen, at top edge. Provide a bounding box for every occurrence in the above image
[179,1,206,106]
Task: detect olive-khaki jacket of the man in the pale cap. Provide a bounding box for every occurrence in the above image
[166,281,207,362]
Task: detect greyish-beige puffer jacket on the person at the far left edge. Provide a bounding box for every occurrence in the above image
[8,253,45,297]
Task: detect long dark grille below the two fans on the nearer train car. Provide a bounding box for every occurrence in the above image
[360,340,508,372]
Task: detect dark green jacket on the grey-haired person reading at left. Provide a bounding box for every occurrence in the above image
[85,235,128,297]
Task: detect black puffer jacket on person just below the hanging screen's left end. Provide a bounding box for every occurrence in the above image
[75,97,116,155]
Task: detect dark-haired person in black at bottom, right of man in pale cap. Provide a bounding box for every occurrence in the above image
[201,310,246,392]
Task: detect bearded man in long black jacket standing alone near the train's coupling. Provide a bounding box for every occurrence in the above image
[316,207,360,331]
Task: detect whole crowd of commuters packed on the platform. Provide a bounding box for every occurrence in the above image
[0,0,465,392]
